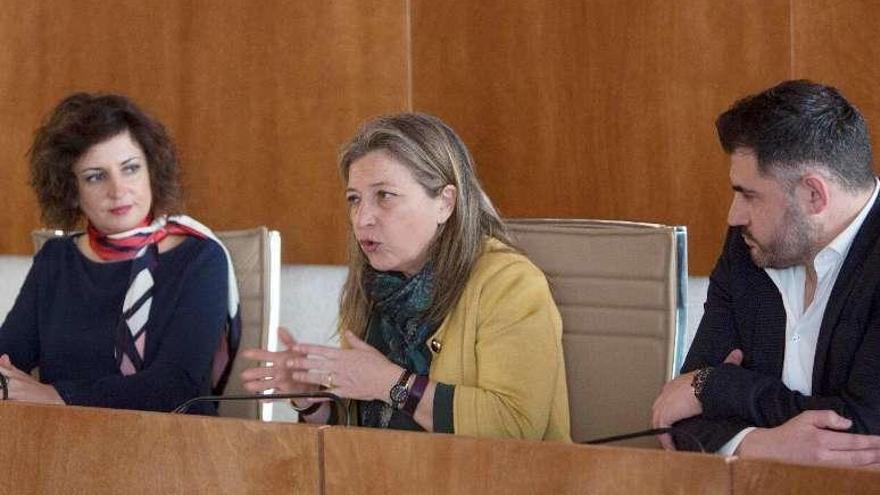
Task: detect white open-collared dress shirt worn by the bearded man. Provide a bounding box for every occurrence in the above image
[718,179,880,455]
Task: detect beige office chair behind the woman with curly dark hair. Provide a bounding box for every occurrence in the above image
[32,227,281,419]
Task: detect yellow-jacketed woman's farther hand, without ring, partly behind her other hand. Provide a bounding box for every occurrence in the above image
[241,327,319,394]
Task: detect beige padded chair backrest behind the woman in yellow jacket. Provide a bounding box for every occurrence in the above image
[508,219,687,446]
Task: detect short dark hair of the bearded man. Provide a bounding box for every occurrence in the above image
[715,80,874,191]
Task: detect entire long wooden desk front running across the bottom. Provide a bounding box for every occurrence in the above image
[0,401,880,495]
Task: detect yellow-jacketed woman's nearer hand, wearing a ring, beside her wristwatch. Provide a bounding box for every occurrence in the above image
[286,332,403,403]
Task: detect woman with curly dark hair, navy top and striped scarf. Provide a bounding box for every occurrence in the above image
[0,93,240,414]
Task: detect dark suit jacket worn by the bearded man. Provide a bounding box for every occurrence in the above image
[673,193,880,451]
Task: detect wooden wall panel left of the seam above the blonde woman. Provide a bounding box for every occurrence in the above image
[0,0,407,263]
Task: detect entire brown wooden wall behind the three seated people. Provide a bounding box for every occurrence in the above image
[6,0,880,274]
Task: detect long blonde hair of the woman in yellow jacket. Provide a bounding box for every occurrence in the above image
[339,113,513,336]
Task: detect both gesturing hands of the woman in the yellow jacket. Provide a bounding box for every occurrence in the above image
[241,327,403,402]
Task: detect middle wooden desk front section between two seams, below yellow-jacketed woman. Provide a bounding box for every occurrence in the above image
[323,428,731,495]
